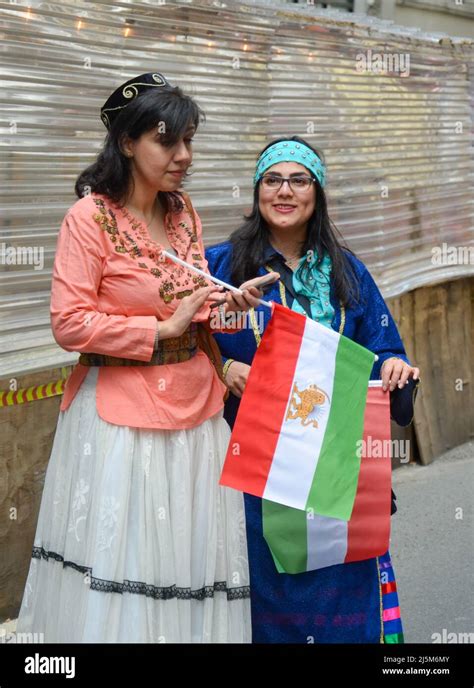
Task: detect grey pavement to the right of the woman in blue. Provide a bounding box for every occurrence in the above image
[390,442,474,643]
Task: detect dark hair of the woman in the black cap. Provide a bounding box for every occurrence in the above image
[74,86,204,211]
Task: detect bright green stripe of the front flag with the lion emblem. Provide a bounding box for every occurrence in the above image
[306,335,374,521]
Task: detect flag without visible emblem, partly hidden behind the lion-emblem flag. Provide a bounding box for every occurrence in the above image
[262,381,392,573]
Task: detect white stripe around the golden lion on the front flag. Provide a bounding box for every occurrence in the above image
[262,318,340,509]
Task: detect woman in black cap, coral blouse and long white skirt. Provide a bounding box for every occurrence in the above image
[17,73,270,642]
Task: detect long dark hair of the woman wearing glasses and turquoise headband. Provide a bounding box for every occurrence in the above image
[229,136,359,306]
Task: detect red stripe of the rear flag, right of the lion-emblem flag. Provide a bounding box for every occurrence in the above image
[344,387,392,563]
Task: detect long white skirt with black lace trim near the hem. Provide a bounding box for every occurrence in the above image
[17,368,251,643]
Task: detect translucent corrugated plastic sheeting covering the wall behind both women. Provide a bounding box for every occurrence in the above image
[0,0,474,376]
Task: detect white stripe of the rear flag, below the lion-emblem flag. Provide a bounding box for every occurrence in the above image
[306,514,348,571]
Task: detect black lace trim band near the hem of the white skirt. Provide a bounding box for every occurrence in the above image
[32,547,250,600]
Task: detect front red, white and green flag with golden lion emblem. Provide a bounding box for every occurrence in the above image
[220,304,375,521]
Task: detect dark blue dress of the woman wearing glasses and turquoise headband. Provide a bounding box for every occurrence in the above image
[206,242,413,643]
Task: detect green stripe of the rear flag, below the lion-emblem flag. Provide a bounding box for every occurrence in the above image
[262,499,308,573]
